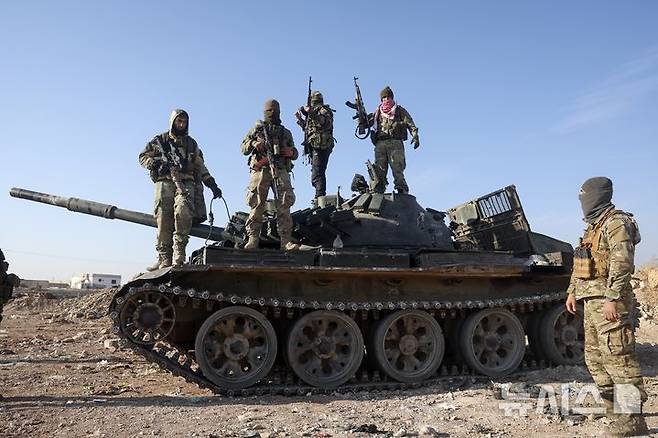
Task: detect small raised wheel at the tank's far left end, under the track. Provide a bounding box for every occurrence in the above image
[119,291,176,345]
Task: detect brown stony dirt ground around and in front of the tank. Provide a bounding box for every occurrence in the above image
[0,286,658,438]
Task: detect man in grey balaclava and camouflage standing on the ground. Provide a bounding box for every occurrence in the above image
[566,177,647,436]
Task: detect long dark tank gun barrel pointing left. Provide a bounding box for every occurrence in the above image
[9,187,231,241]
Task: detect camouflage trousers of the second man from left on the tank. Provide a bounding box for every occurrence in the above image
[245,167,295,243]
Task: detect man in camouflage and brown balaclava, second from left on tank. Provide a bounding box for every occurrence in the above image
[241,99,299,251]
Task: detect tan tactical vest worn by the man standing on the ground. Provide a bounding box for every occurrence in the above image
[573,209,639,280]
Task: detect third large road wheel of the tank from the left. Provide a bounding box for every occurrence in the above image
[372,310,445,383]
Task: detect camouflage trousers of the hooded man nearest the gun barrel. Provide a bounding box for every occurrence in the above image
[155,180,194,266]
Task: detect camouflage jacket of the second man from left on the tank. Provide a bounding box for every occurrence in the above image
[240,120,299,172]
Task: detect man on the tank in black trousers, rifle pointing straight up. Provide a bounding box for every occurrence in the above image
[295,91,334,199]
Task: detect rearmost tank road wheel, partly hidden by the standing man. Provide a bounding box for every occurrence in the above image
[539,304,585,365]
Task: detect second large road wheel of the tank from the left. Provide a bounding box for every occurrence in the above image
[286,310,363,388]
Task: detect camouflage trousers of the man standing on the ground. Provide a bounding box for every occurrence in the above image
[584,298,647,401]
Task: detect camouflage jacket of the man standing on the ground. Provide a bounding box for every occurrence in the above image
[567,210,640,300]
